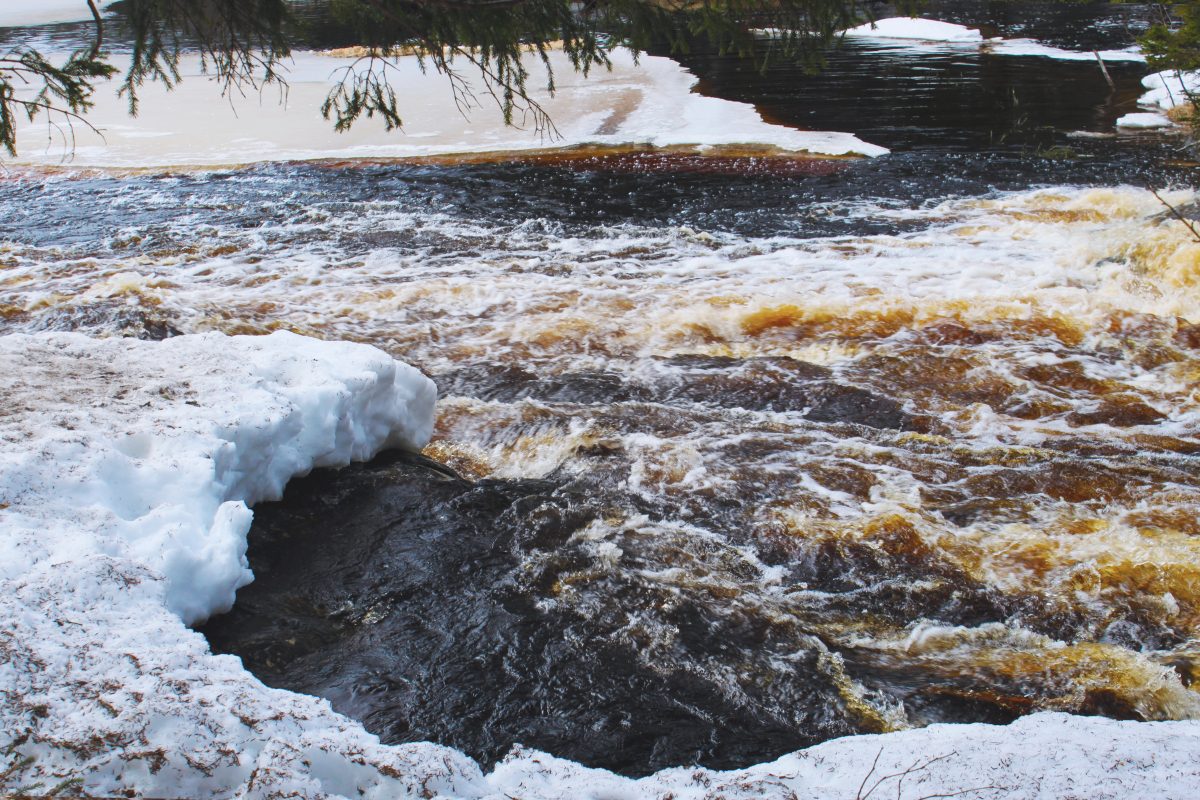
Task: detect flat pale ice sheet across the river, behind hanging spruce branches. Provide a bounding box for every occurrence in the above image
[11,50,887,167]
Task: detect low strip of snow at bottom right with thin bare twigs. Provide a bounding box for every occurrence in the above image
[487,714,1200,800]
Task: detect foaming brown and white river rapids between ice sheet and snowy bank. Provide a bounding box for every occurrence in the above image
[0,0,1200,772]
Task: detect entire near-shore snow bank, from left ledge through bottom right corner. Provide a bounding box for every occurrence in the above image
[0,333,1200,800]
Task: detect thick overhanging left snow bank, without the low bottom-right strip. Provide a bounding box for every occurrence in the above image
[0,333,479,796]
